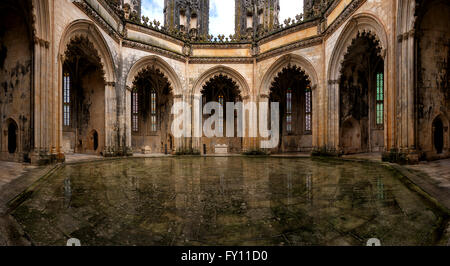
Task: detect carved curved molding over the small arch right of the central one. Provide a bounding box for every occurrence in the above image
[259,54,319,97]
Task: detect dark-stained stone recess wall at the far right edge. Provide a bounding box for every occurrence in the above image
[417,1,450,158]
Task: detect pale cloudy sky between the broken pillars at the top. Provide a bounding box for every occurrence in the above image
[142,0,303,36]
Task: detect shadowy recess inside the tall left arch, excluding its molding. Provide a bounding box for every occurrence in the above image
[61,36,106,155]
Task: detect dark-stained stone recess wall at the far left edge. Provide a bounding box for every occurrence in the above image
[0,1,33,161]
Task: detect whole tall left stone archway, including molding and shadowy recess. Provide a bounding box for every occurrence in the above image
[57,20,119,156]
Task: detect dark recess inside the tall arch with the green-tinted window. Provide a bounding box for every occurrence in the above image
[339,33,385,154]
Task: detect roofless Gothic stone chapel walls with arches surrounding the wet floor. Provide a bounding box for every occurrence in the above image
[0,0,450,164]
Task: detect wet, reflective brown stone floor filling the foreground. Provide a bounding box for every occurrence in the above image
[11,157,443,246]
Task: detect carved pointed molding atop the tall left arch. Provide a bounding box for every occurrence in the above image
[58,19,116,85]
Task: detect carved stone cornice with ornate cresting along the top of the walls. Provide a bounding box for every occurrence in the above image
[81,0,356,57]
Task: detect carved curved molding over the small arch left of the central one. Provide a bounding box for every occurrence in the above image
[126,55,182,95]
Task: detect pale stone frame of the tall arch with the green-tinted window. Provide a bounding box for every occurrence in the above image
[327,13,390,153]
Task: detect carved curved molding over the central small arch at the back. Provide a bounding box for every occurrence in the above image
[192,65,250,99]
